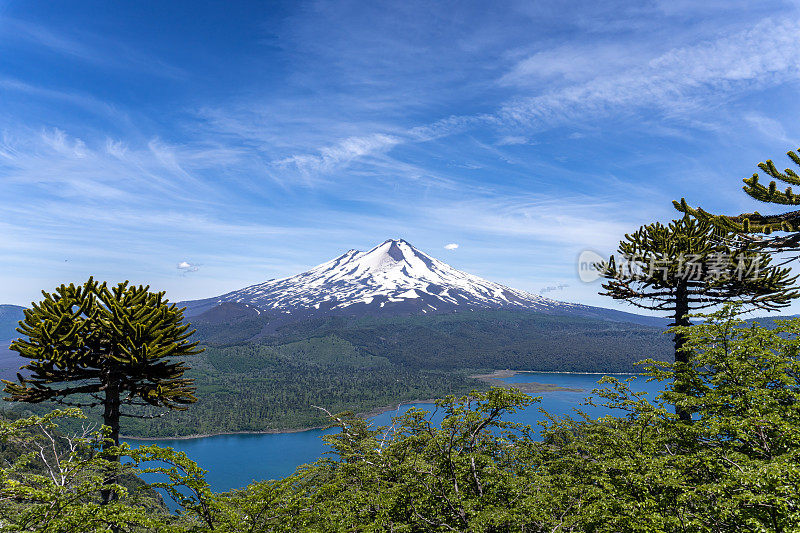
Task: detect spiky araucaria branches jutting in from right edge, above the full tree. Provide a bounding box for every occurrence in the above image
[673,149,800,249]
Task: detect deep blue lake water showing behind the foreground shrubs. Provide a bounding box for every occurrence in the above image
[123,372,663,491]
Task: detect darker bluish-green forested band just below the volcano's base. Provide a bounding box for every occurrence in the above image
[193,310,670,372]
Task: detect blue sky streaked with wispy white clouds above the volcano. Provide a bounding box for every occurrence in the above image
[0,0,800,312]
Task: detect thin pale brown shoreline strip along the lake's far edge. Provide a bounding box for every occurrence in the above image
[119,369,635,442]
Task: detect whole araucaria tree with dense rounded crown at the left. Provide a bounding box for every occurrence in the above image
[3,278,200,498]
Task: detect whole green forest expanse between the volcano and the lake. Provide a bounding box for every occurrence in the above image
[3,310,671,437]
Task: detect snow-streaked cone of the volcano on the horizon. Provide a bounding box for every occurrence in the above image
[191,239,579,313]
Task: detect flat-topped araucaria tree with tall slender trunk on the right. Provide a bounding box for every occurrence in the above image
[597,216,800,420]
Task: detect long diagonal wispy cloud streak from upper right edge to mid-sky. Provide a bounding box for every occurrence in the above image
[252,18,800,182]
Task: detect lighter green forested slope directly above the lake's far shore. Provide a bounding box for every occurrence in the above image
[123,337,487,437]
